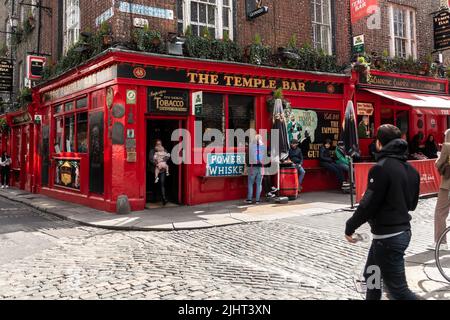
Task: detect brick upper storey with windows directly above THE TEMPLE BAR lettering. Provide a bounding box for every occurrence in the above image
[73,0,350,63]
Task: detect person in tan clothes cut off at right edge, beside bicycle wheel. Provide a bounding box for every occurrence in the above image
[429,129,450,250]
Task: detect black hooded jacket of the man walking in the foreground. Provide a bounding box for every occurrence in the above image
[345,139,420,236]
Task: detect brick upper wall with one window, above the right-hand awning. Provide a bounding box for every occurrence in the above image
[352,0,441,60]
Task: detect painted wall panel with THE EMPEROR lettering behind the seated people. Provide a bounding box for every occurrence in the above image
[287,108,342,160]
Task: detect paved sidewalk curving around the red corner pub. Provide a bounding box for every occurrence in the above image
[0,189,350,231]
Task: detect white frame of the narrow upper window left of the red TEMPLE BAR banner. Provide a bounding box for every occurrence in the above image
[310,0,333,55]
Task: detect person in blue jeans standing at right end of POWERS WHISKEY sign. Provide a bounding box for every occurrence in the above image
[246,134,267,204]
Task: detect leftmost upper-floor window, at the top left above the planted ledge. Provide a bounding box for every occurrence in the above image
[64,0,80,52]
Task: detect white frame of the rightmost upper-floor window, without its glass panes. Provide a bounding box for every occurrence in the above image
[388,5,417,59]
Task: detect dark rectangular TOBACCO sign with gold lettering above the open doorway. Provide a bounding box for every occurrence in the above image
[148,88,189,115]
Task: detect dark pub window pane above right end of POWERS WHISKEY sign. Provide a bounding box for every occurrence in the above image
[228,95,255,146]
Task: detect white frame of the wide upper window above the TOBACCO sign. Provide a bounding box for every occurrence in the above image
[177,0,234,40]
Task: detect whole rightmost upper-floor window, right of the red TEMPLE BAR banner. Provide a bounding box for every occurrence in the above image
[389,6,417,59]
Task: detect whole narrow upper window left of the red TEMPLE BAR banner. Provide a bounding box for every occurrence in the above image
[311,0,333,54]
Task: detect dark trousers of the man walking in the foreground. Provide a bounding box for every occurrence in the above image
[364,231,418,300]
